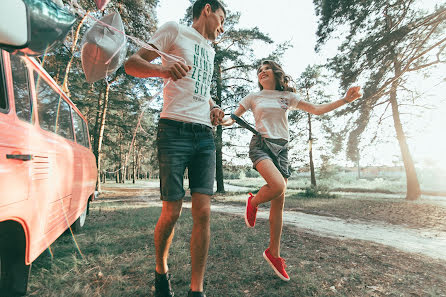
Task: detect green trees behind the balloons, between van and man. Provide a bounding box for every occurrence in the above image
[43,0,161,183]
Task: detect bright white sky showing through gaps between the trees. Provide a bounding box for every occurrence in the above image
[157,0,446,172]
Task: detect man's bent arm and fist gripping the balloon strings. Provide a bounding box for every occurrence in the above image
[124,48,192,81]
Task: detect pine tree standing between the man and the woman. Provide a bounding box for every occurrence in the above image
[183,0,290,192]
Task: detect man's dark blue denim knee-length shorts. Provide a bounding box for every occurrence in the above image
[157,119,215,201]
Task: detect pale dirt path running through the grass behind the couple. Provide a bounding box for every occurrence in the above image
[100,184,446,260]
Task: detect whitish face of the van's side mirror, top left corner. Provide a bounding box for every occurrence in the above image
[0,0,31,49]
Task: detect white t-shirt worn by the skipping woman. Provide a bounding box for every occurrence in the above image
[240,90,301,140]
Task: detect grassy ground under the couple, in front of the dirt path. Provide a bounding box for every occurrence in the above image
[28,188,446,297]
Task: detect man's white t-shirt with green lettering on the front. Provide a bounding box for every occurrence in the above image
[149,22,215,127]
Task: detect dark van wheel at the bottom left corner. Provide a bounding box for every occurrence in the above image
[0,250,31,296]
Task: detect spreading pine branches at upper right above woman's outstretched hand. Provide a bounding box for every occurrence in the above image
[313,0,446,161]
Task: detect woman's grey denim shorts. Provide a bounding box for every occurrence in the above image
[249,135,291,178]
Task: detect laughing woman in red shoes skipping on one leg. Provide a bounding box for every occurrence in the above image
[221,60,361,281]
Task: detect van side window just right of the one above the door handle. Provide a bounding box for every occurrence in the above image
[34,72,60,132]
